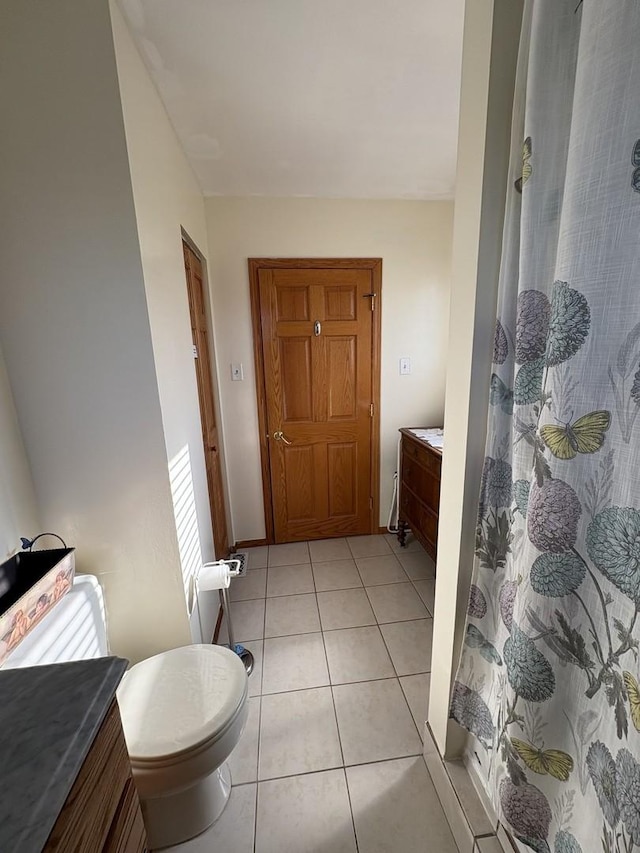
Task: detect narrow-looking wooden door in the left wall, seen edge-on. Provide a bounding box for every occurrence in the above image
[182,242,229,560]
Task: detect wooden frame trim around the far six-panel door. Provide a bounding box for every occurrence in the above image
[245,258,382,547]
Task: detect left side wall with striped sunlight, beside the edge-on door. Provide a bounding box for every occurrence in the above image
[110,6,226,636]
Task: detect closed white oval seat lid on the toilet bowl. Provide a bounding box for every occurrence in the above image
[117,645,247,761]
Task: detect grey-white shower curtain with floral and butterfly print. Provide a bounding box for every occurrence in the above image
[451,0,640,853]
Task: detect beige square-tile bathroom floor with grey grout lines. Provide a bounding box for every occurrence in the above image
[165,536,456,853]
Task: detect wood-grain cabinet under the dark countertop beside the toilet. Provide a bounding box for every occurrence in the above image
[44,700,148,853]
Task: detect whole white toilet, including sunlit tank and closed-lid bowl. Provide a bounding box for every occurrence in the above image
[3,575,248,848]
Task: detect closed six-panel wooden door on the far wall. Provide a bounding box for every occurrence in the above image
[250,261,379,542]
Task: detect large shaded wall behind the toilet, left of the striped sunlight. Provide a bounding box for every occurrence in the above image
[0,0,190,660]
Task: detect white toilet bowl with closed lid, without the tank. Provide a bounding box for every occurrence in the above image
[118,645,248,848]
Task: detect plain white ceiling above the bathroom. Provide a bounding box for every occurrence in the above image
[120,0,464,199]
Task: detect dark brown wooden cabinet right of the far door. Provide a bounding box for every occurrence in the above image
[398,428,442,560]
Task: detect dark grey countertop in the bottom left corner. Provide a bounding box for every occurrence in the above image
[0,657,127,853]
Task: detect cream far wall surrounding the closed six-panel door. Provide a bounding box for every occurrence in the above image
[206,198,453,541]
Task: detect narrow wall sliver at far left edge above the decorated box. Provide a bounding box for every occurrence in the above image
[0,351,42,561]
